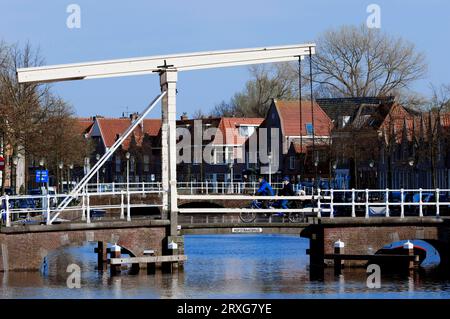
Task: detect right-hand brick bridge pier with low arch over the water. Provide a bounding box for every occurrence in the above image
[301,217,450,269]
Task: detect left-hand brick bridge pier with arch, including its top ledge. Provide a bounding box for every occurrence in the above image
[0,220,170,271]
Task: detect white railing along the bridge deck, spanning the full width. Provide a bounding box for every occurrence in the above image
[0,188,450,227]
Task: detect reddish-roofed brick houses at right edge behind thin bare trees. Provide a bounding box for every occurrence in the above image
[379,105,450,189]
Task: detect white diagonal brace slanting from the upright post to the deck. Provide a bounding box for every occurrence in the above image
[47,91,166,225]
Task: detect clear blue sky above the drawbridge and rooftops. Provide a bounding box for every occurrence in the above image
[0,0,450,117]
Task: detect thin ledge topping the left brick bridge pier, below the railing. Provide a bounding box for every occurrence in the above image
[0,219,170,234]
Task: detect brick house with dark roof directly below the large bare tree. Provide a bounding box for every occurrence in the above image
[316,97,394,188]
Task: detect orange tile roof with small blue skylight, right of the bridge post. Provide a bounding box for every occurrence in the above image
[274,100,332,136]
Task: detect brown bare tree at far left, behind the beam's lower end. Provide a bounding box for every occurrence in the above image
[0,44,91,192]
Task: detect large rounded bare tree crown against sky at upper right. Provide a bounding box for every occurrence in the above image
[313,25,427,97]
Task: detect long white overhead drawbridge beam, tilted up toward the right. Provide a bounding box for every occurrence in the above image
[17,43,316,83]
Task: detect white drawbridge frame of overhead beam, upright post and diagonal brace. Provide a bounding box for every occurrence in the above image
[17,43,315,230]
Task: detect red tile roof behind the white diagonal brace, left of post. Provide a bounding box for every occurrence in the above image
[97,118,161,149]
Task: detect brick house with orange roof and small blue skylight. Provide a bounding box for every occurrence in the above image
[259,99,332,179]
